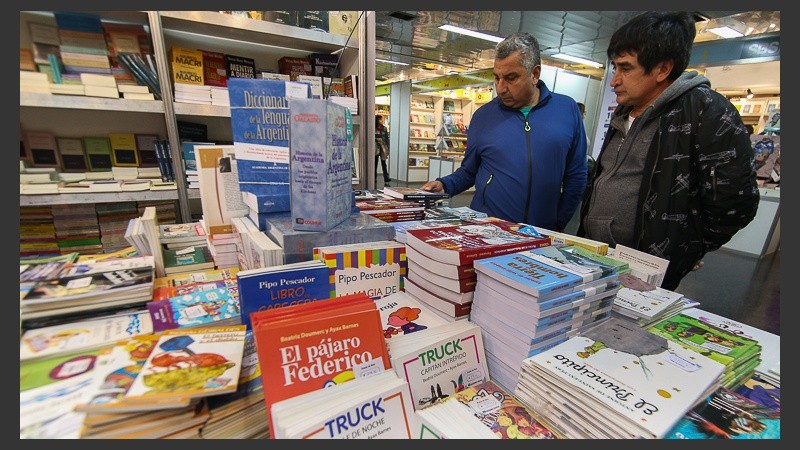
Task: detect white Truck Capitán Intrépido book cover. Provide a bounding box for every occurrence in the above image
[388,321,489,410]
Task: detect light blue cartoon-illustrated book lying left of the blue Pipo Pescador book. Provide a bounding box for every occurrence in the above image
[147,285,241,332]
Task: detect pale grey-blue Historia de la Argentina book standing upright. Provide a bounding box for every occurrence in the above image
[289,99,353,231]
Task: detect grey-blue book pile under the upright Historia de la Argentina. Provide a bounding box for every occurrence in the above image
[264,213,394,264]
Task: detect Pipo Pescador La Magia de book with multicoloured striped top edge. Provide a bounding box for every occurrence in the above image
[314,241,408,300]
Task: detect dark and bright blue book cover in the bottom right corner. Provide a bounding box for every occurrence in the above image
[665,388,781,439]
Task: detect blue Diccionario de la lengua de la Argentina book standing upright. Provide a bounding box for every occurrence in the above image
[228,78,311,193]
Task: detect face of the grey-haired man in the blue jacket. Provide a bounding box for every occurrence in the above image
[494,52,542,109]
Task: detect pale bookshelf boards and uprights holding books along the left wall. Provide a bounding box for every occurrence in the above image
[20,11,368,222]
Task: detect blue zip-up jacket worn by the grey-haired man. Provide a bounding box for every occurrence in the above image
[438,80,587,230]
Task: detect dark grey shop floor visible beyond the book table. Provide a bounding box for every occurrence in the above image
[377,179,781,335]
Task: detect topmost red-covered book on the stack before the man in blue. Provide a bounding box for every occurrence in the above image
[406,221,550,265]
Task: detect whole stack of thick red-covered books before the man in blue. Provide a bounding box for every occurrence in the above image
[406,219,550,320]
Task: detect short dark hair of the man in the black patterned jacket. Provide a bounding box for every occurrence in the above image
[606,11,697,81]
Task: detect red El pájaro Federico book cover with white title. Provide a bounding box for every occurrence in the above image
[250,293,391,436]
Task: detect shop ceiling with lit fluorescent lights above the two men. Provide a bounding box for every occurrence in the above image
[375,11,780,84]
